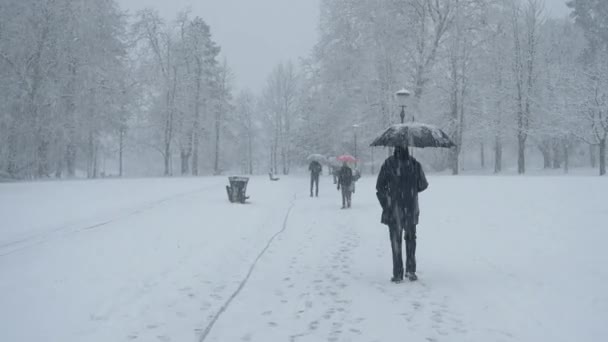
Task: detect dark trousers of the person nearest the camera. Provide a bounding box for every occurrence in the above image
[388,224,416,279]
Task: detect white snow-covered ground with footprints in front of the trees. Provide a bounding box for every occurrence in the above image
[0,176,608,342]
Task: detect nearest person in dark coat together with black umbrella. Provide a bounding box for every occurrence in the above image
[372,123,454,283]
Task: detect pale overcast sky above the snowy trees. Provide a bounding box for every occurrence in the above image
[117,0,568,93]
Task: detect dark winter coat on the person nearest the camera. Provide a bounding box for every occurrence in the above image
[376,149,429,225]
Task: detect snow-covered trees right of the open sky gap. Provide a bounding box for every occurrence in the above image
[235,0,608,175]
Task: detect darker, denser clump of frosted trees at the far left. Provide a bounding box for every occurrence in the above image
[0,0,127,177]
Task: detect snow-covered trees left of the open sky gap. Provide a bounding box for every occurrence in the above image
[0,0,232,178]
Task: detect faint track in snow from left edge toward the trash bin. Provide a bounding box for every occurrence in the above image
[0,186,213,257]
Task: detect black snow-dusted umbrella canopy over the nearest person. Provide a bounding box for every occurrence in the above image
[371,122,456,148]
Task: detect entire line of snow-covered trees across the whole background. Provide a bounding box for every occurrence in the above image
[0,0,608,177]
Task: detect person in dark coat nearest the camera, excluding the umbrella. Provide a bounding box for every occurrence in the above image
[376,147,429,282]
